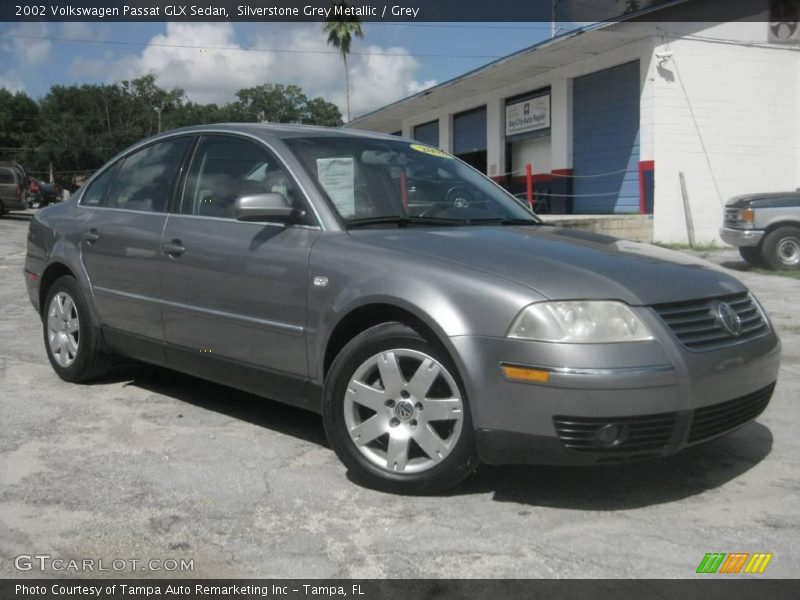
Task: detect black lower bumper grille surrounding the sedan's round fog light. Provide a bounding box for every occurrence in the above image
[553,412,677,454]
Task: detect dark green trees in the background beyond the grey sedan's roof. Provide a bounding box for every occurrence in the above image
[0,75,342,187]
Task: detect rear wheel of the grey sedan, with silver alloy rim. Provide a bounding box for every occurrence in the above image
[42,275,109,383]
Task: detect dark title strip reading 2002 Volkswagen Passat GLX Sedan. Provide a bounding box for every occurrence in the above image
[0,0,800,22]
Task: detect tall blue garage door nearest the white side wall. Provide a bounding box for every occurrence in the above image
[572,61,640,214]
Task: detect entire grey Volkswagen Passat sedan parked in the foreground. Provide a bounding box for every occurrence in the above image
[25,124,780,493]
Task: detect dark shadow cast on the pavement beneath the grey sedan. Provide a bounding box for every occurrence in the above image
[97,361,773,511]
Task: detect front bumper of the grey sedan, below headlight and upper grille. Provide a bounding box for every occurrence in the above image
[451,318,780,464]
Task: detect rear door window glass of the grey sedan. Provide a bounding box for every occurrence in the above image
[105,137,190,212]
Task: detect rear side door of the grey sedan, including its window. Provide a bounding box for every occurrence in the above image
[81,136,192,341]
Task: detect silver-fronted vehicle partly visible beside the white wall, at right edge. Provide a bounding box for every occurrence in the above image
[720,190,800,270]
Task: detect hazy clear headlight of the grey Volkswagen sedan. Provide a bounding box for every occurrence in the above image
[508,301,653,344]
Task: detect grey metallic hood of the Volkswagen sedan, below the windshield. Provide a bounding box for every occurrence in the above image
[350,225,746,305]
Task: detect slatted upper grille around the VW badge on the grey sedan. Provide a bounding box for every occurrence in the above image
[653,292,768,350]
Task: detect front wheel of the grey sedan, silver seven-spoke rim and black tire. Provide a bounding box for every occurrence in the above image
[323,323,477,494]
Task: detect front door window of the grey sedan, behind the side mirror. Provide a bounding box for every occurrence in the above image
[180,135,314,225]
